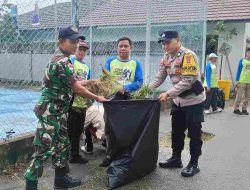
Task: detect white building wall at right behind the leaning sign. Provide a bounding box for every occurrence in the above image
[208,22,246,80]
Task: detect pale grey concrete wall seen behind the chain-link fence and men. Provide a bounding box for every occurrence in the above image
[0,53,170,88]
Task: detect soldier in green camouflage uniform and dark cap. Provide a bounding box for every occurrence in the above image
[24,27,106,190]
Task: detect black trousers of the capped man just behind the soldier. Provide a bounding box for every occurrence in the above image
[67,107,86,156]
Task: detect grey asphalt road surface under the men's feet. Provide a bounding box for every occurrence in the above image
[0,101,250,190]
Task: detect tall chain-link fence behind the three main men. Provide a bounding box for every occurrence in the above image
[0,0,207,139]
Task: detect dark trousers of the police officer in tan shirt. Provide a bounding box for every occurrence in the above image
[171,103,204,162]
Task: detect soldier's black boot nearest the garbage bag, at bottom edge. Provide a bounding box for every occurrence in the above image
[54,175,82,189]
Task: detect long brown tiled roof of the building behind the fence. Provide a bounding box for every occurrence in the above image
[18,0,250,29]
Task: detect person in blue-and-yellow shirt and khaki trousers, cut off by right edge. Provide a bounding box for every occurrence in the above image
[234,48,250,115]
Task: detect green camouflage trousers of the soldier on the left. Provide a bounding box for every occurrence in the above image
[24,112,70,181]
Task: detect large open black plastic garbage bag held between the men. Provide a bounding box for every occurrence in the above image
[104,100,160,189]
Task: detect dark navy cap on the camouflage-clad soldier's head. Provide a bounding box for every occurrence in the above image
[59,26,85,40]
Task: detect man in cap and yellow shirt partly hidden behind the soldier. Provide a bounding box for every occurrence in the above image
[68,40,92,164]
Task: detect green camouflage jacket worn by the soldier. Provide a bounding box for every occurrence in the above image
[34,50,77,117]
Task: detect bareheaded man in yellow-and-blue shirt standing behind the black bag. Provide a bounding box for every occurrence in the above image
[100,37,143,167]
